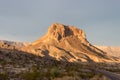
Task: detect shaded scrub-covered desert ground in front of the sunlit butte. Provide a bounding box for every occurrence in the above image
[0,49,119,80]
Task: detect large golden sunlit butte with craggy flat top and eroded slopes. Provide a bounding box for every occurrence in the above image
[22,23,114,62]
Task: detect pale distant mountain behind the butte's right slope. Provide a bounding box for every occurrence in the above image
[95,45,120,58]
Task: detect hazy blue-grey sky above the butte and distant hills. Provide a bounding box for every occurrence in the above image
[0,0,120,46]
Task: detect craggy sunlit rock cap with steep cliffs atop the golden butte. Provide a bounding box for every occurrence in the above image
[48,24,85,41]
